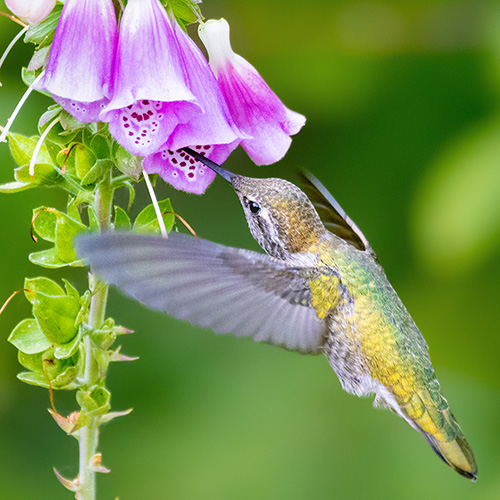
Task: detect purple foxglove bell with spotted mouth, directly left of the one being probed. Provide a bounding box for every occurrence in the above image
[101,0,203,156]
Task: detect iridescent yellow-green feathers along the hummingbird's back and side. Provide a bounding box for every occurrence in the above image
[311,244,446,440]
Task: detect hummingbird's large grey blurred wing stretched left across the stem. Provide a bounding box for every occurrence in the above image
[76,232,326,354]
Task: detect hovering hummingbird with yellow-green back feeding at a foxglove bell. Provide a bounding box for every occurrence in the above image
[76,148,477,481]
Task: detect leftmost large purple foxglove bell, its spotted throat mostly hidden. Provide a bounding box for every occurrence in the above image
[37,0,118,123]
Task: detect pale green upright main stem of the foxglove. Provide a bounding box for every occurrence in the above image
[79,173,113,500]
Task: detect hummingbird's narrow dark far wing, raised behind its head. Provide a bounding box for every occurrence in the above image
[299,170,376,257]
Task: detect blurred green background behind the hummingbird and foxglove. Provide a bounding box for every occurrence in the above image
[0,0,500,500]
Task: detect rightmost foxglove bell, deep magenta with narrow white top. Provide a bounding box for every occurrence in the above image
[199,19,306,165]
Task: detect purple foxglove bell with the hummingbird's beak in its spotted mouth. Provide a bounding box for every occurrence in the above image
[143,26,246,194]
